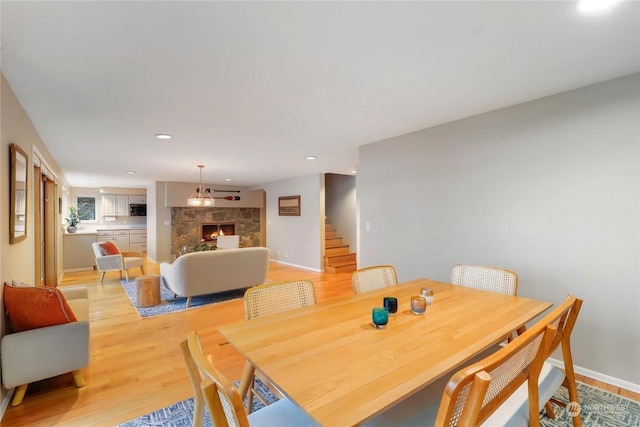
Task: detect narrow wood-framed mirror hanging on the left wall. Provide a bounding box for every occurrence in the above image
[9,144,28,243]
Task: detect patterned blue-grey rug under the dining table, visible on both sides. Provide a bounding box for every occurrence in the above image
[118,379,640,427]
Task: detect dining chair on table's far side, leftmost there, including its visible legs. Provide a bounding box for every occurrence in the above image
[240,280,316,413]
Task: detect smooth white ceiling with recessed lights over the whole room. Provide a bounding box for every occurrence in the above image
[0,0,640,187]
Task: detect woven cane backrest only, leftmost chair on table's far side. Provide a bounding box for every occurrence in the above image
[244,280,316,320]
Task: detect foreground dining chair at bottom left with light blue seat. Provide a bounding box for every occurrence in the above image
[180,331,317,427]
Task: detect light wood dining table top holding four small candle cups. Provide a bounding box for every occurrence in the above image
[218,279,551,426]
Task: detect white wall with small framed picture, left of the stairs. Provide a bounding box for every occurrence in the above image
[260,175,324,271]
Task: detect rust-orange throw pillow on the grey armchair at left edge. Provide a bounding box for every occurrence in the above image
[4,283,77,332]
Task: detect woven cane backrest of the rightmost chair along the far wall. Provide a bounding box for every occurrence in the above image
[451,264,518,295]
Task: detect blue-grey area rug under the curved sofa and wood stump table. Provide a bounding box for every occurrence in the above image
[120,280,246,317]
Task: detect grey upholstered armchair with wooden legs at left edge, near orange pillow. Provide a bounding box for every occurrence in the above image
[0,285,89,406]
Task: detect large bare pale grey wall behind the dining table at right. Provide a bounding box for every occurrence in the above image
[357,74,640,387]
